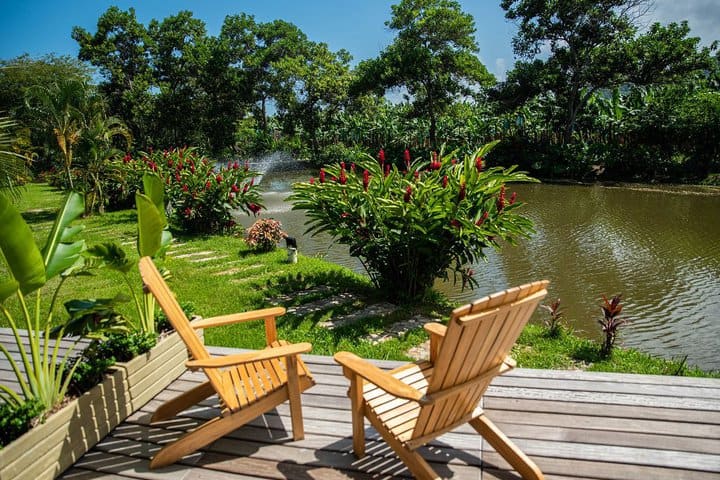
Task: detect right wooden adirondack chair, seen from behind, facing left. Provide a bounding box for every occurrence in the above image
[335,281,548,479]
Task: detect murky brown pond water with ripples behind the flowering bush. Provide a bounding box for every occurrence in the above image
[238,159,720,369]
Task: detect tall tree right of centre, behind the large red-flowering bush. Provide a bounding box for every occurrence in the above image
[354,0,495,148]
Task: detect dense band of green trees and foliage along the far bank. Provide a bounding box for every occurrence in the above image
[0,0,720,184]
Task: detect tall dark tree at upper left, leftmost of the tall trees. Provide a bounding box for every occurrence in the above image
[72,7,154,143]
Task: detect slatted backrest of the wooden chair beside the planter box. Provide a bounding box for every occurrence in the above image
[139,257,244,411]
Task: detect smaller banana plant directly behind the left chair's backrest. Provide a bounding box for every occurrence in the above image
[88,174,172,334]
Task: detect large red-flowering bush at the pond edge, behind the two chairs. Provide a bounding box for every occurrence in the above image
[289,142,537,301]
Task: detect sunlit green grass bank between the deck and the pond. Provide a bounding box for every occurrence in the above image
[0,184,720,377]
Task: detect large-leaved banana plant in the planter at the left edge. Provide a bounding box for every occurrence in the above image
[0,192,90,411]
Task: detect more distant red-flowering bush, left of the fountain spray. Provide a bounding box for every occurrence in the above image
[115,147,262,233]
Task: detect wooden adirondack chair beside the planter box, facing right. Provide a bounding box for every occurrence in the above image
[139,257,315,468]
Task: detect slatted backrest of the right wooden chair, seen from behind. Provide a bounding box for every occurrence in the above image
[412,281,548,438]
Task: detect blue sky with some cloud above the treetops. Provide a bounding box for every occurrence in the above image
[0,0,720,79]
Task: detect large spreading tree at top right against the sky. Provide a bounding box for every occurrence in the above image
[501,0,709,143]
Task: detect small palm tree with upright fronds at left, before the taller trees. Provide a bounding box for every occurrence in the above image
[25,78,98,189]
